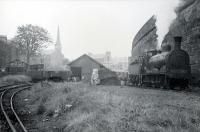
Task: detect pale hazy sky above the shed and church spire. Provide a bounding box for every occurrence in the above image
[0,0,179,60]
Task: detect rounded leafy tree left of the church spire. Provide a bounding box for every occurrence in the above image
[13,24,52,64]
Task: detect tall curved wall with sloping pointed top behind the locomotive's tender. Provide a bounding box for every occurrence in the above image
[128,16,158,74]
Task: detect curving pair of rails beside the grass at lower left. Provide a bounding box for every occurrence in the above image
[0,84,31,132]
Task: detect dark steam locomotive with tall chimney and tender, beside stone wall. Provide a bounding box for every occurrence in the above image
[129,36,191,89]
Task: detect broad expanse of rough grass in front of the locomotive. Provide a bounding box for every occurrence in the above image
[17,83,200,132]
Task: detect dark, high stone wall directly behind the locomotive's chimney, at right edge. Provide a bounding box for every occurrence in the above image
[162,0,200,81]
